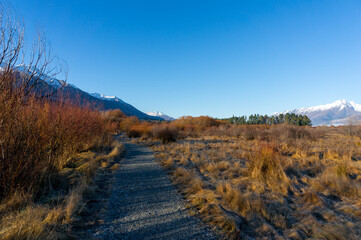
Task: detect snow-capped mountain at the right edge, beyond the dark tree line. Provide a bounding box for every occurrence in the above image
[274,99,361,126]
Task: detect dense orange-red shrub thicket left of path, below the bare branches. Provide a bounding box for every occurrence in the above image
[0,95,106,199]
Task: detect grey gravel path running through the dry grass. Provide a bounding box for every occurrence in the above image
[94,143,217,239]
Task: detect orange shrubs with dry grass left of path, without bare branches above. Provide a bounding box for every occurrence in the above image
[0,76,124,239]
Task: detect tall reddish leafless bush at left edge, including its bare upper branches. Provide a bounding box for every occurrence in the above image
[0,5,104,199]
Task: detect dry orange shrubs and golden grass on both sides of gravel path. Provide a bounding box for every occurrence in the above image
[0,6,361,240]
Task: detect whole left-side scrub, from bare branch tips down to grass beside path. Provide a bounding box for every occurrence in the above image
[0,9,124,239]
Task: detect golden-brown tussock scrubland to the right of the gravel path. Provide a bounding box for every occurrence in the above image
[123,117,361,239]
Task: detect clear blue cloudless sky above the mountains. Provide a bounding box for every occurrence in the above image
[11,0,361,117]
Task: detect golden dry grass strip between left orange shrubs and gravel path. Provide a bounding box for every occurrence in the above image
[0,141,124,240]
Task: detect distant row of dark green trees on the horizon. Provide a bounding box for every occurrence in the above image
[222,113,312,126]
